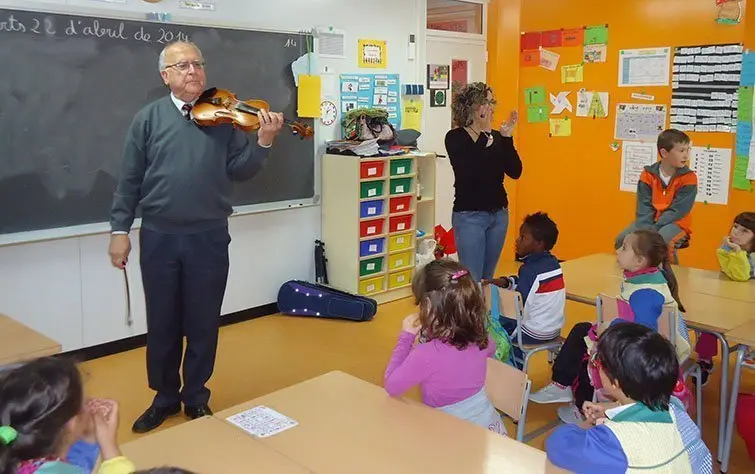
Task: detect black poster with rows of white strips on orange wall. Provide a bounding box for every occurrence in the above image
[671,44,742,133]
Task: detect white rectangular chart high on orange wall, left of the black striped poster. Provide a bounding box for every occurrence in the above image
[619,48,671,87]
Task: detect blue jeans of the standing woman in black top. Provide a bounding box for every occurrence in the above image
[451,209,509,281]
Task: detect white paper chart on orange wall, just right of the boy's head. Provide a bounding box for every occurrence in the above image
[690,146,731,205]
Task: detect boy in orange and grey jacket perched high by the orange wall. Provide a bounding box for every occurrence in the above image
[615,129,697,262]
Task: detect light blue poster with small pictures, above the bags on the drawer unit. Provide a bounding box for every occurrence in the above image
[341,74,401,130]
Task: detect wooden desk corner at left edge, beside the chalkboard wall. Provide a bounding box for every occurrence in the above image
[0,314,61,366]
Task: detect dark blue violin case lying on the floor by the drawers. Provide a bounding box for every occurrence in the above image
[278,280,377,321]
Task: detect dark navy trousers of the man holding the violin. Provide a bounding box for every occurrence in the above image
[139,227,231,407]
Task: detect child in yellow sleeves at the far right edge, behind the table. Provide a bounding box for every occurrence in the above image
[695,212,755,385]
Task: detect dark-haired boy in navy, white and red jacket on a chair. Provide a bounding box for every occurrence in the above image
[483,212,566,344]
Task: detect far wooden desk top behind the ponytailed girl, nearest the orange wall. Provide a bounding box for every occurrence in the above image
[561,253,755,303]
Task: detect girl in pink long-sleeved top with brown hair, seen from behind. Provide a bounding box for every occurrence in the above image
[385,259,506,435]
